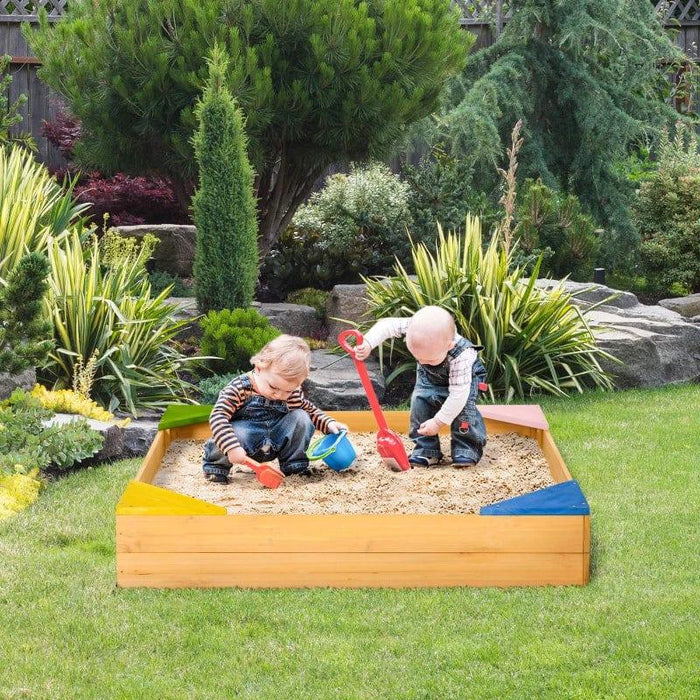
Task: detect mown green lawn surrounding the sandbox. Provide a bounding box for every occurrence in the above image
[0,385,700,699]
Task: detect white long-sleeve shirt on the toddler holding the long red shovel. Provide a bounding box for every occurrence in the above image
[364,318,477,425]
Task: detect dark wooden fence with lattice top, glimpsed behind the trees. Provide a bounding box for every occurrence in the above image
[0,0,700,167]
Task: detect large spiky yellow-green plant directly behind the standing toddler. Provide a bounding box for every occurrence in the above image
[367,217,612,401]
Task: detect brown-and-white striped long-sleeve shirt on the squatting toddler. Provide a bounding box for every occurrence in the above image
[209,374,333,454]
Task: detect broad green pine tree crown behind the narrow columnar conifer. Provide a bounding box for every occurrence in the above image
[25,0,474,255]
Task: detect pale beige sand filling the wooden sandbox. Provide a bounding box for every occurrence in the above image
[153,433,554,514]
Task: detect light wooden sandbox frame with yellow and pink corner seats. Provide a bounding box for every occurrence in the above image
[116,406,590,588]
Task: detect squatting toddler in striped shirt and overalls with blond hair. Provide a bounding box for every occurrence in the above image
[203,335,347,484]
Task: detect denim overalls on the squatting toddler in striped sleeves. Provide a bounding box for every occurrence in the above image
[203,377,315,476]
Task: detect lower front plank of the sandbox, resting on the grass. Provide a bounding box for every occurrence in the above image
[117,552,583,588]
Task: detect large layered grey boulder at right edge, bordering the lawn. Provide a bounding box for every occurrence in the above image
[587,304,700,389]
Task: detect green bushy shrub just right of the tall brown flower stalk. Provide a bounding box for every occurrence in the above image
[514,179,599,281]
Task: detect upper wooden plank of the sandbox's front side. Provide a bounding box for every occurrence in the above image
[117,514,584,553]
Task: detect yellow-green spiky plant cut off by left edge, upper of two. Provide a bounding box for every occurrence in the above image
[0,146,89,279]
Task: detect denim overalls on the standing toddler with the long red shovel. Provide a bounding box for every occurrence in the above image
[409,338,486,464]
